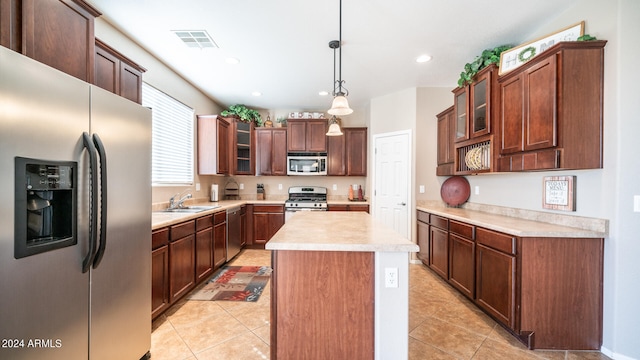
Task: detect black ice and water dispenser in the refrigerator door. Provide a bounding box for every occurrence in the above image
[14,157,77,259]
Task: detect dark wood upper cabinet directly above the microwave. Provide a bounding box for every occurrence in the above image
[287,119,327,152]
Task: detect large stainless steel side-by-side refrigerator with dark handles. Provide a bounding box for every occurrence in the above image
[0,47,151,360]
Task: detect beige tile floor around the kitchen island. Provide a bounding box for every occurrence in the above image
[151,249,609,360]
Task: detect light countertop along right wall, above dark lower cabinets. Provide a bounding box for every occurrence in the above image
[416,204,607,238]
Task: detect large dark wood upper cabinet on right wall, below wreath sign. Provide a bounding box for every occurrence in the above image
[498,41,607,171]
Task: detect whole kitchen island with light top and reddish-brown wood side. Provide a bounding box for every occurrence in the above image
[266,211,419,360]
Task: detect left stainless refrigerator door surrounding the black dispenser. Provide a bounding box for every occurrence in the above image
[0,47,89,360]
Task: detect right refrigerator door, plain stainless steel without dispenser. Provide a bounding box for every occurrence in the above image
[90,86,151,360]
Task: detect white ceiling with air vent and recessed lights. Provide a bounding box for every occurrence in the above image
[89,0,578,111]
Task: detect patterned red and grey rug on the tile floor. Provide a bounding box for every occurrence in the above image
[188,266,271,302]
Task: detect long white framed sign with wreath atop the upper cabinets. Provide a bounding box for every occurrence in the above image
[498,21,584,75]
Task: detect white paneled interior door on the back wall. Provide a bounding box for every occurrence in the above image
[373,131,411,239]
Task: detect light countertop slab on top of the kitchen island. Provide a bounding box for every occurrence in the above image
[265,211,419,252]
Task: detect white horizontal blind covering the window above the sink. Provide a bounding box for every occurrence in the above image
[142,82,194,185]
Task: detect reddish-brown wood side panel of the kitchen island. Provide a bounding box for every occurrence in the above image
[271,250,375,360]
